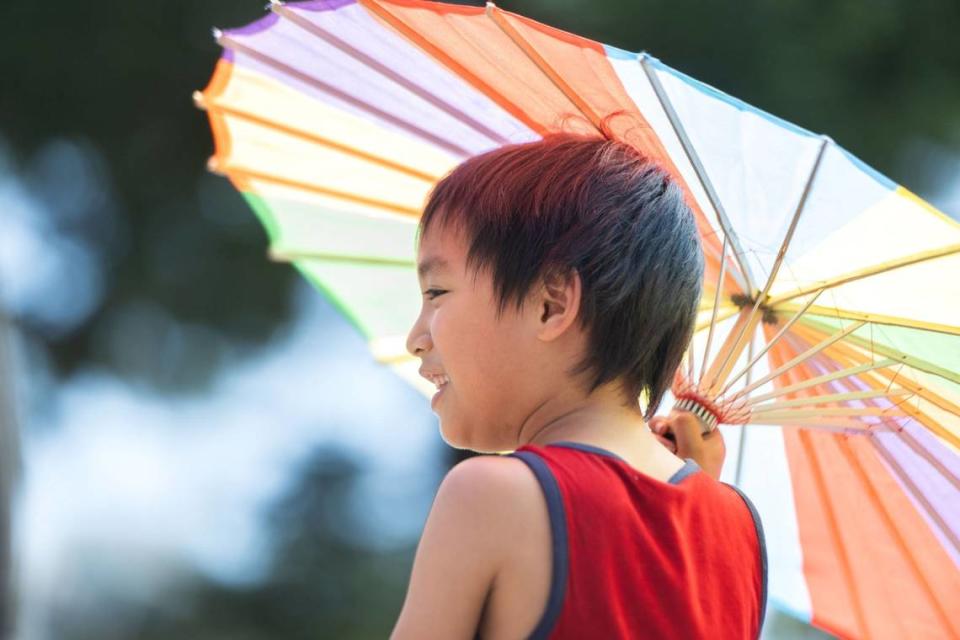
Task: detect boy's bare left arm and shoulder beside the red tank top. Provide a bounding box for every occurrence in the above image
[390,456,539,640]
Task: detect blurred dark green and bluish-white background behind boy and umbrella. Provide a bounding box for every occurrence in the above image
[0,0,960,640]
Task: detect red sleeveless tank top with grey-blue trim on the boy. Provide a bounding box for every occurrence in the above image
[507,442,767,640]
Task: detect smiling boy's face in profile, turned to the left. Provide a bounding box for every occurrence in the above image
[407,222,545,452]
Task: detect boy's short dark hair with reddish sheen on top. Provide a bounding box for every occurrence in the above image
[418,133,704,418]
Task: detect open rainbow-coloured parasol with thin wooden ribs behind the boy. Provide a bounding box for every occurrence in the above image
[194,0,960,638]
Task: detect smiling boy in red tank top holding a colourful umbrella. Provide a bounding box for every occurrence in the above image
[391,134,765,640]
